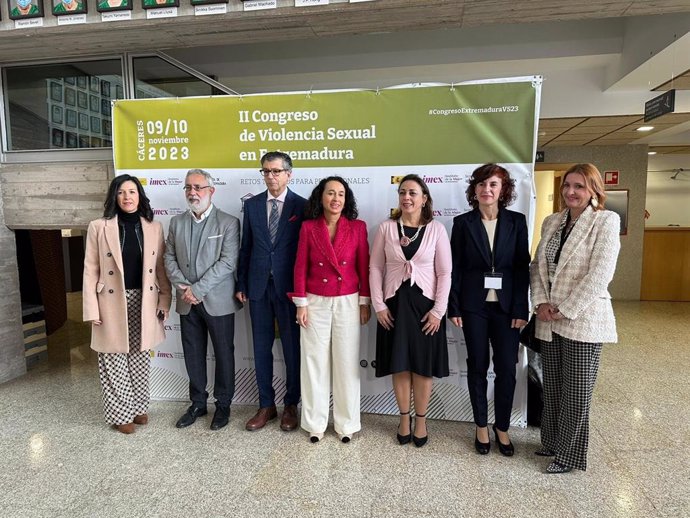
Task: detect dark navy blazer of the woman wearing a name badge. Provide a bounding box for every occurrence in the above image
[448,209,529,320]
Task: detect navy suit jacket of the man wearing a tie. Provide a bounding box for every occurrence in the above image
[237,189,307,302]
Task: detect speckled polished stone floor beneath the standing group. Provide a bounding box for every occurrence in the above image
[0,302,690,517]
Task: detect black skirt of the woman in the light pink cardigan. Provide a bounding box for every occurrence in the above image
[376,280,450,378]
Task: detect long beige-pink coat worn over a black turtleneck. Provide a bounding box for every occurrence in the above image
[83,216,172,353]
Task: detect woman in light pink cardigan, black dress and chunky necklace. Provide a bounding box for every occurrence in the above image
[369,174,452,447]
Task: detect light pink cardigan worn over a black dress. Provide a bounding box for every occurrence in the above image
[369,219,452,318]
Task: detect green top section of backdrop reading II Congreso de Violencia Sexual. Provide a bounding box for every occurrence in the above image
[113,81,537,169]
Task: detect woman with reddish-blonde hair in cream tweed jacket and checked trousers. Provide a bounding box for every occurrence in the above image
[530,164,620,473]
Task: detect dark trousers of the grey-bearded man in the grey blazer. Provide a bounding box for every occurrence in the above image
[180,302,235,407]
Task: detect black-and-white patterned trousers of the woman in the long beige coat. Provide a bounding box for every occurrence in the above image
[98,290,151,425]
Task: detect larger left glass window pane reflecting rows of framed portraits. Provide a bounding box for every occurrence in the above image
[4,59,124,151]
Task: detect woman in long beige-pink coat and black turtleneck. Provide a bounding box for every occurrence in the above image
[83,175,171,433]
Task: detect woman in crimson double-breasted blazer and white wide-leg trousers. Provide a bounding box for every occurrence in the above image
[288,176,371,443]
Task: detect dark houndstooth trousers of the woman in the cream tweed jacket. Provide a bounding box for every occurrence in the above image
[541,333,602,471]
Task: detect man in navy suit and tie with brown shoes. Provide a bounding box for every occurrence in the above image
[235,151,307,431]
